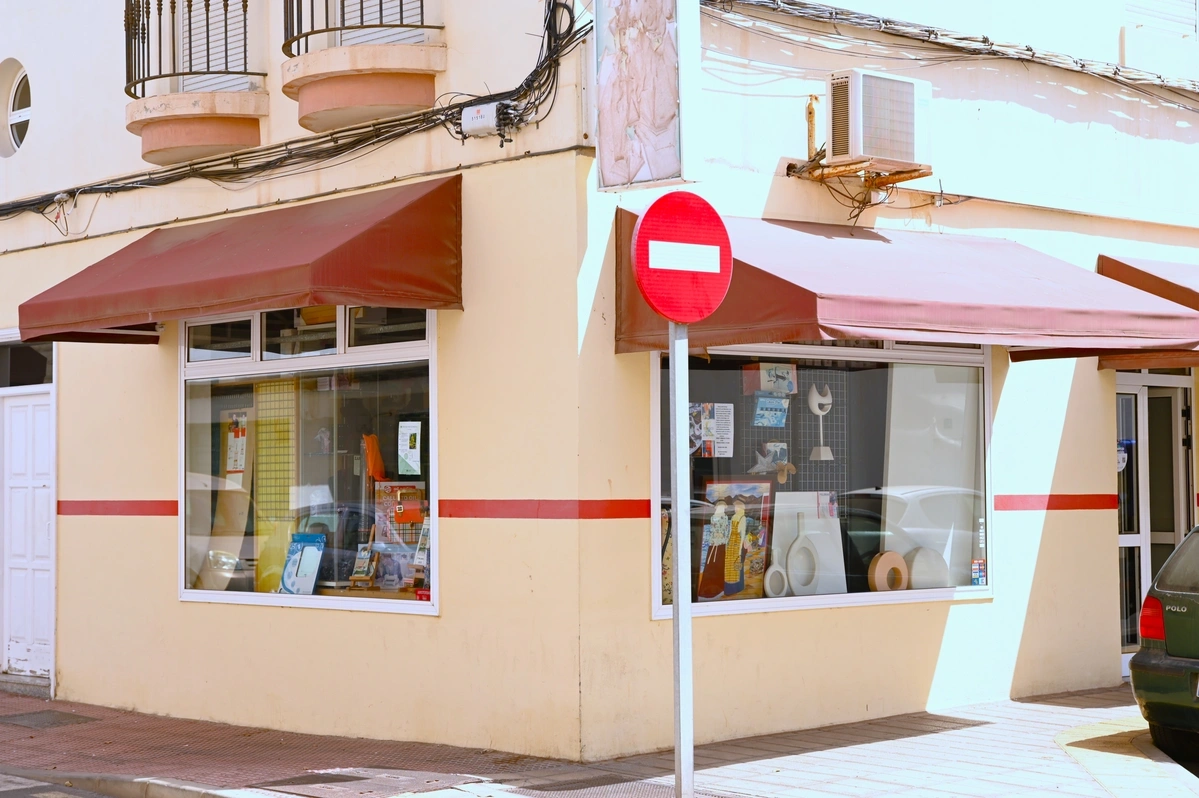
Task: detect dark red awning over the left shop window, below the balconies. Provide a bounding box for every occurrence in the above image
[20,175,462,343]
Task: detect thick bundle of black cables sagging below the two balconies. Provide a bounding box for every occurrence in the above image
[0,0,592,224]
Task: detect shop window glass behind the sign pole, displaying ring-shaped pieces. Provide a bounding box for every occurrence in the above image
[659,352,988,605]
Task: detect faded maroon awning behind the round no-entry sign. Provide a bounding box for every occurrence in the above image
[616,208,1199,352]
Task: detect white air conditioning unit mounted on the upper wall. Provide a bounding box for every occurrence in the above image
[825,69,933,171]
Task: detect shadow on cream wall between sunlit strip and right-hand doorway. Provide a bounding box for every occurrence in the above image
[1010,358,1120,697]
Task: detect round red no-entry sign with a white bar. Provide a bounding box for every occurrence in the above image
[633,192,733,325]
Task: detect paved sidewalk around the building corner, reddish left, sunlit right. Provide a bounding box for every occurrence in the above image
[0,687,1199,798]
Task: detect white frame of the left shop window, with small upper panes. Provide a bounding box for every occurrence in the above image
[177,306,441,616]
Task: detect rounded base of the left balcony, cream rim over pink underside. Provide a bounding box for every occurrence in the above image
[125,91,269,167]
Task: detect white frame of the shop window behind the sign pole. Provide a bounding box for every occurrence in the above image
[650,344,995,621]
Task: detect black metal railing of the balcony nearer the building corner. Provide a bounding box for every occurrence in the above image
[283,0,441,58]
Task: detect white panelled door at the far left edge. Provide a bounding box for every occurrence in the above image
[0,393,54,677]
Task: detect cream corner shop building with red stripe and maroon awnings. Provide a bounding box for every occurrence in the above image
[0,0,1199,760]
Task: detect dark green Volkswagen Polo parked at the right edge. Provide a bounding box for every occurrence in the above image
[1128,527,1199,754]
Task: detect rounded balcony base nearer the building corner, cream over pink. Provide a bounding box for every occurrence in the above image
[283,44,446,133]
